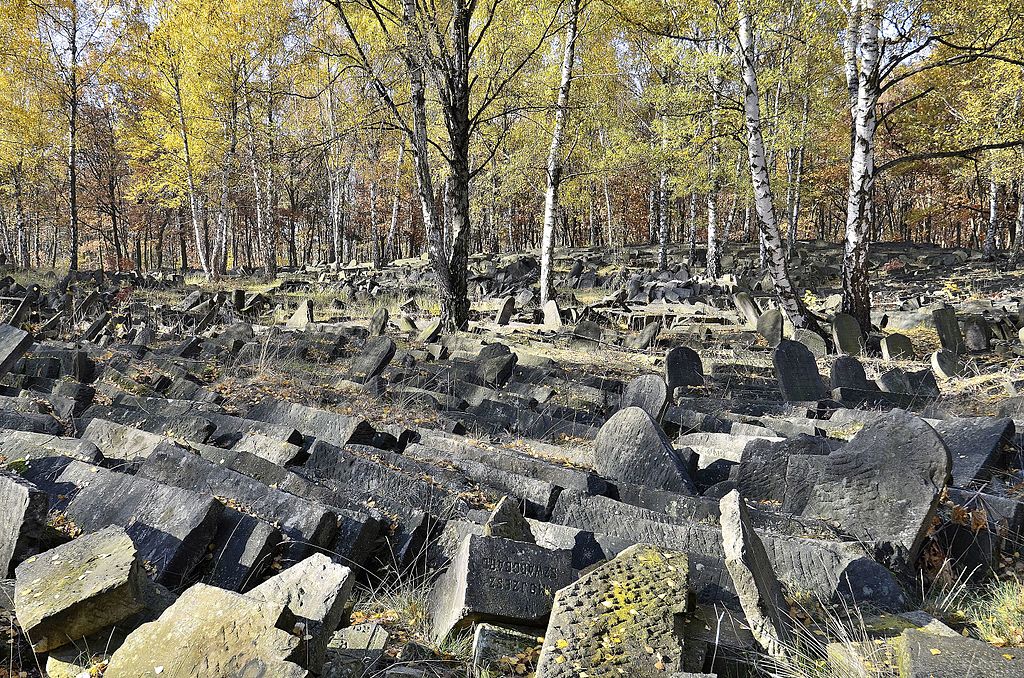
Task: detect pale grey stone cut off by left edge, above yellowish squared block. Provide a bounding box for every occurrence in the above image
[0,469,49,579]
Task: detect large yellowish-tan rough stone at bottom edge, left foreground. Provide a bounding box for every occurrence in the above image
[103,584,308,678]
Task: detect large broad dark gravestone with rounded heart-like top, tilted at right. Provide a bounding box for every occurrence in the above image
[782,410,952,568]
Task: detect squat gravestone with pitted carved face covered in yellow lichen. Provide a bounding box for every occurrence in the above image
[537,544,693,678]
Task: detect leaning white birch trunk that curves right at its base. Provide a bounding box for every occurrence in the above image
[737,0,820,332]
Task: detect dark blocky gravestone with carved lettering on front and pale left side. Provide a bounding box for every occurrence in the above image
[431,535,573,640]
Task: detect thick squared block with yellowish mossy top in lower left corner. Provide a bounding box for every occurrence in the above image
[14,526,145,652]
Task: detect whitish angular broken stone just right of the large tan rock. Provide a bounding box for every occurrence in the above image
[248,553,355,673]
